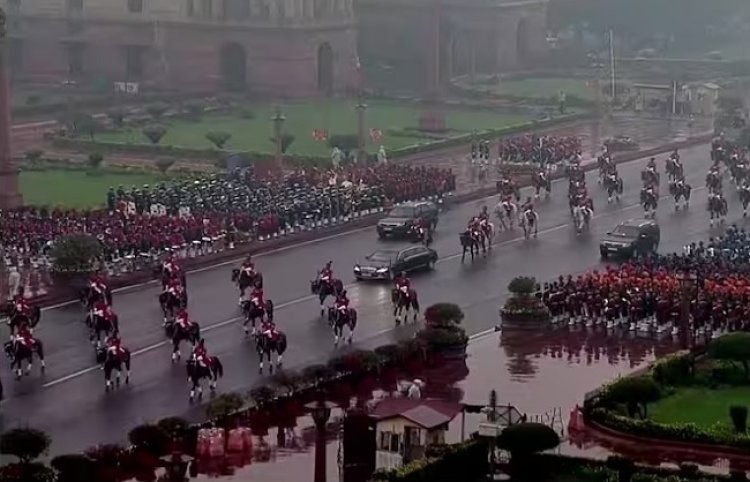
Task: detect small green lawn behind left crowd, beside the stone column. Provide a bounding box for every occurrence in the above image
[20,170,159,208]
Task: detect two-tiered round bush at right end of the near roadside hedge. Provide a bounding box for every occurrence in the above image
[416,303,469,358]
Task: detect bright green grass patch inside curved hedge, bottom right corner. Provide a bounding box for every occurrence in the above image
[649,387,750,428]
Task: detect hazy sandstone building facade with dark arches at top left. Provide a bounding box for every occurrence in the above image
[2,0,357,96]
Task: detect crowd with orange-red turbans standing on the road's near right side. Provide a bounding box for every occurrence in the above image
[538,226,750,336]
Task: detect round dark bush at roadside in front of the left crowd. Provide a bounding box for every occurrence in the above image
[50,234,102,294]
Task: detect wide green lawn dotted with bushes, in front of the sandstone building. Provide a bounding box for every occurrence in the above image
[91,100,531,156]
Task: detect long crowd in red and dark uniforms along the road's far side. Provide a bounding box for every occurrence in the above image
[0,164,455,264]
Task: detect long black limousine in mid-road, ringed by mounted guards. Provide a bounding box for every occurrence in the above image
[354,246,437,281]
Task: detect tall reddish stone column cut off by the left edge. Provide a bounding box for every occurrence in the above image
[0,9,22,209]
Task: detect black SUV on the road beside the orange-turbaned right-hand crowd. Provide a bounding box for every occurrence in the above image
[599,219,661,258]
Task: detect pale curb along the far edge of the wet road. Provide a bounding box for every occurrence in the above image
[30,134,713,307]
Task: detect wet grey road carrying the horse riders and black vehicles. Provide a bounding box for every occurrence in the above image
[0,141,741,453]
